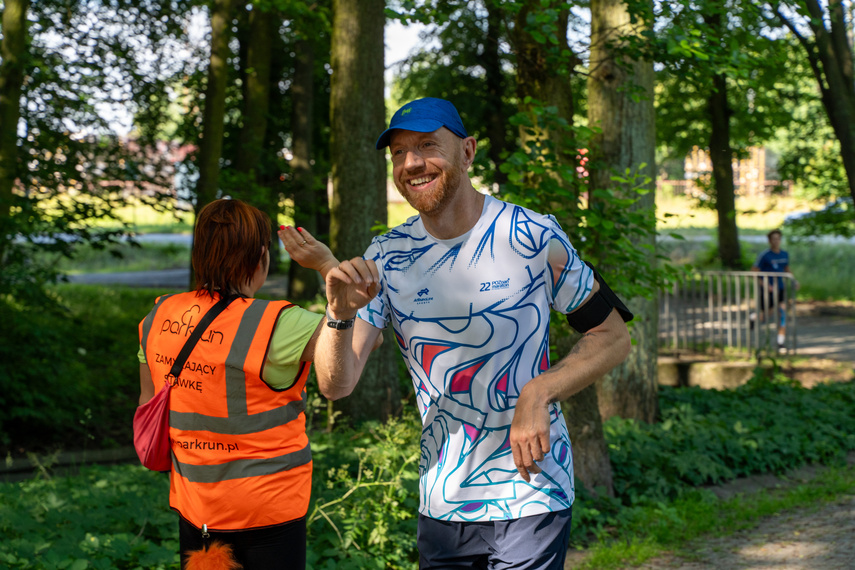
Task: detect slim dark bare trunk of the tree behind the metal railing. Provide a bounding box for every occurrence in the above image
[707,71,745,270]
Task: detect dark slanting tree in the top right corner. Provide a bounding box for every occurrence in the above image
[764,0,855,205]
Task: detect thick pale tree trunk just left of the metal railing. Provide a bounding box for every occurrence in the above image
[588,0,659,422]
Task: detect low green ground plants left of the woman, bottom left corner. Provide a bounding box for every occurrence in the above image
[0,465,178,570]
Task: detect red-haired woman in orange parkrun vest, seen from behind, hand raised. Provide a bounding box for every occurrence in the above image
[139,199,376,569]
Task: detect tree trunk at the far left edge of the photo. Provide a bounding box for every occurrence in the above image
[0,0,29,264]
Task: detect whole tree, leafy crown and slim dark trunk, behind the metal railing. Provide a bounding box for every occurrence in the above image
[656,0,785,269]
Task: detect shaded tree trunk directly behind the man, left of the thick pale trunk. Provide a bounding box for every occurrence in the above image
[510,0,614,495]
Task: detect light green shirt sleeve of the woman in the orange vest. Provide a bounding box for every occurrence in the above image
[261,306,323,390]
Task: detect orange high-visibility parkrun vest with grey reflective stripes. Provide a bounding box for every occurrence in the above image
[140,292,312,530]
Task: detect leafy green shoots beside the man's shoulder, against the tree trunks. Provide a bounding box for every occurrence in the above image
[502,99,677,298]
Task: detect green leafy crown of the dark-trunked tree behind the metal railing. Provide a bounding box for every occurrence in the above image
[650,0,791,168]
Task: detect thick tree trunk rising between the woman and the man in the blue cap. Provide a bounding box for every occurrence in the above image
[330,0,400,420]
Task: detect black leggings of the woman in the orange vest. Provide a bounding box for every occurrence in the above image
[178,517,306,570]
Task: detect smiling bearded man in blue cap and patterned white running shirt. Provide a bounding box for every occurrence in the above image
[318,98,632,569]
